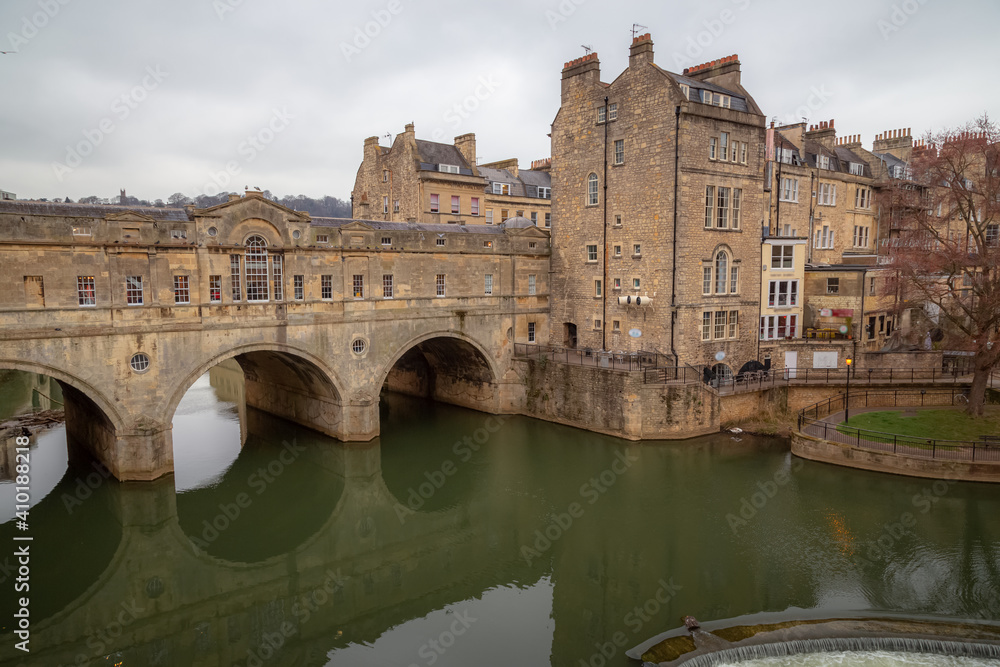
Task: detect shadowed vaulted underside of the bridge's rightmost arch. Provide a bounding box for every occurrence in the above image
[379,330,503,413]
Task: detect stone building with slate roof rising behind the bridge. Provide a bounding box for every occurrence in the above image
[351,123,552,225]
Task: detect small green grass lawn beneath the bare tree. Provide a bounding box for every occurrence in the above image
[838,405,1000,440]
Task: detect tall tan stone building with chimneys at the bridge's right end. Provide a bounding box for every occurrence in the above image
[550,34,765,375]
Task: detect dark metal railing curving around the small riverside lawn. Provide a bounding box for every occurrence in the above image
[798,387,1000,462]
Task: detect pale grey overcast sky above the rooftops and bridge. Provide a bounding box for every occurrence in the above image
[0,0,1000,200]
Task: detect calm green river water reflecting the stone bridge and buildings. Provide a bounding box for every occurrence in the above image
[0,369,1000,666]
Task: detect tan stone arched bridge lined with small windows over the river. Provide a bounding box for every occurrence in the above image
[0,192,549,480]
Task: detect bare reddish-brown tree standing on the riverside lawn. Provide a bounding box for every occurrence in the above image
[882,115,1000,415]
